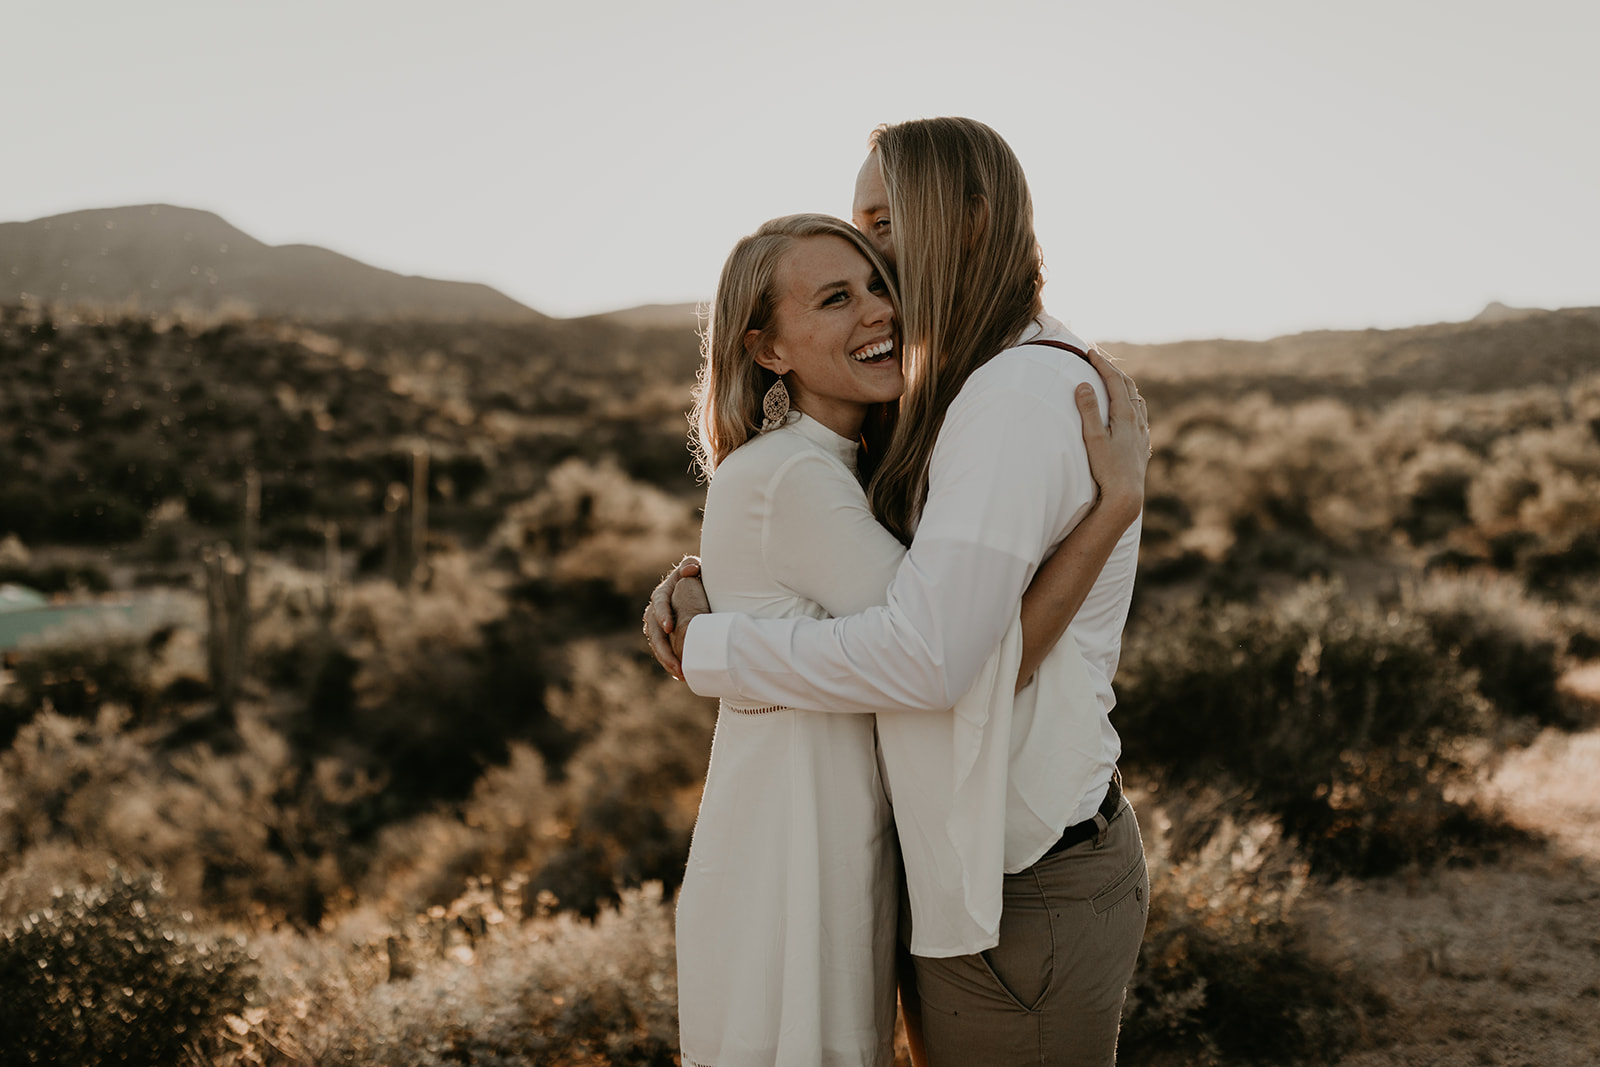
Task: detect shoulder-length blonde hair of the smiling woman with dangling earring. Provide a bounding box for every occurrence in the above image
[690,214,899,478]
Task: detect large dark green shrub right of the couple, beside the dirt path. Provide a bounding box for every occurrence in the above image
[1117,582,1485,873]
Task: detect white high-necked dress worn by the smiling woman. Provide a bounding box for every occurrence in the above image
[677,416,904,1067]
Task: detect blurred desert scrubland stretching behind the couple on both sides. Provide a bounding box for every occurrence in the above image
[0,307,1600,1064]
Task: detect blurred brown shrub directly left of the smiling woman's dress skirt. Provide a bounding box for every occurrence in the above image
[362,640,715,918]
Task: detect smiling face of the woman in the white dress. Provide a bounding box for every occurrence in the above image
[747,234,906,437]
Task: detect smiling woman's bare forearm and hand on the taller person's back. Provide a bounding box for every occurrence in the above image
[1016,349,1150,691]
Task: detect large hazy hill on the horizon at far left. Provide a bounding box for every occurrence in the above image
[0,203,542,322]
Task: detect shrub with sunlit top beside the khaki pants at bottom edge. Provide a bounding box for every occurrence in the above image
[1118,809,1384,1065]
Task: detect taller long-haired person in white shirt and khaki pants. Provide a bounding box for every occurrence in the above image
[659,118,1147,1067]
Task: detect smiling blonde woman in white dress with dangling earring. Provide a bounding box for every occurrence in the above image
[677,214,1142,1067]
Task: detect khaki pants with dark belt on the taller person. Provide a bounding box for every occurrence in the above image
[915,800,1150,1067]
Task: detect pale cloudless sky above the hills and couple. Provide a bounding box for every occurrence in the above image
[0,0,1600,341]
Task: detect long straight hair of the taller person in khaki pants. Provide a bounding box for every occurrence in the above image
[867,118,1045,544]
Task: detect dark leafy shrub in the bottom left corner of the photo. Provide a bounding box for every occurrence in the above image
[0,872,254,1067]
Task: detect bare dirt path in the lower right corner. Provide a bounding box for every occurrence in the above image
[1301,700,1600,1067]
